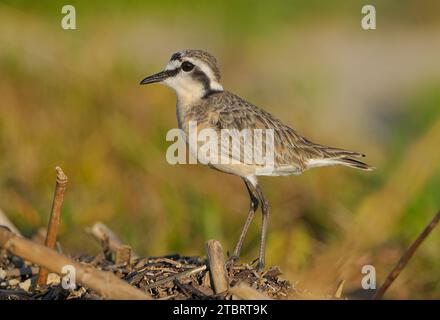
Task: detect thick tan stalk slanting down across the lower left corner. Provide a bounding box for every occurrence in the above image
[0,227,151,300]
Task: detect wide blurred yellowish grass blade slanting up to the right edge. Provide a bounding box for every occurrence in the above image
[300,118,440,291]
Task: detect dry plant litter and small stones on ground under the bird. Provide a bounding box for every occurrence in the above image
[0,251,297,300]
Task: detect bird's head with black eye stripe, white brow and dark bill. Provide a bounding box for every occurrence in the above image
[140,50,223,100]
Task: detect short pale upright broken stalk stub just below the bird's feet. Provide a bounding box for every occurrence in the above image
[206,240,229,294]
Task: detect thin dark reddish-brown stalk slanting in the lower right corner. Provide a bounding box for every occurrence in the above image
[373,211,440,300]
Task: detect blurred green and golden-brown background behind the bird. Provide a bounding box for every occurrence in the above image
[0,0,440,299]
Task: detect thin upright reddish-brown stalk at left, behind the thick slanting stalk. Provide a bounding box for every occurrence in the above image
[37,167,68,285]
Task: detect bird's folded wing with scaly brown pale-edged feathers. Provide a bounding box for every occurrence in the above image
[208,92,368,171]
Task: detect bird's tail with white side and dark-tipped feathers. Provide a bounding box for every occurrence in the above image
[307,147,375,171]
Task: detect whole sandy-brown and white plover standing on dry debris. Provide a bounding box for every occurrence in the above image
[140,50,373,269]
